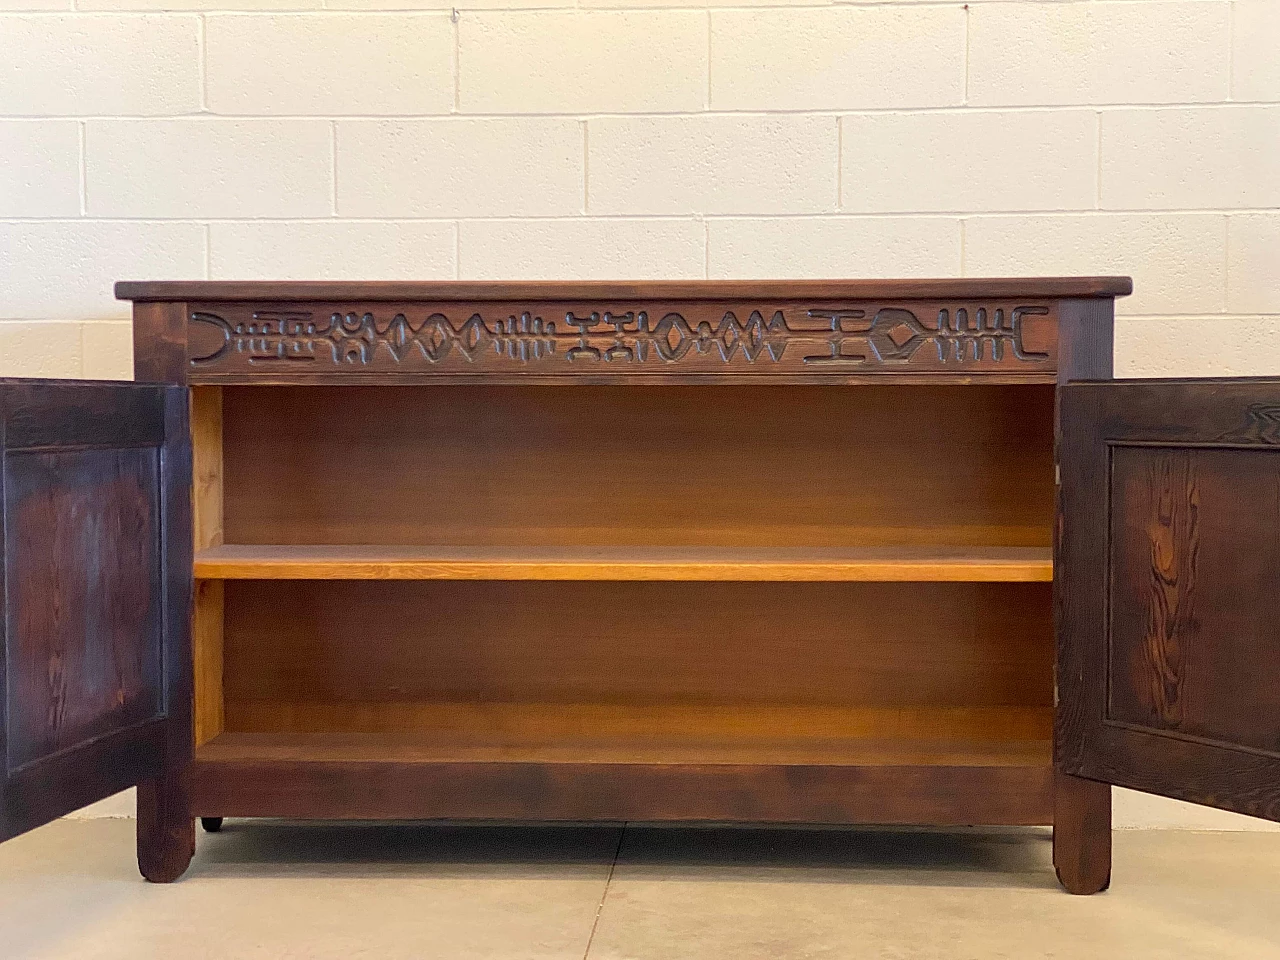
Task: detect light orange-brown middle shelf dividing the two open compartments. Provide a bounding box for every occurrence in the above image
[196,544,1053,582]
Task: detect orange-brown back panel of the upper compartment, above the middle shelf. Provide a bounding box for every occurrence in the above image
[223,385,1053,548]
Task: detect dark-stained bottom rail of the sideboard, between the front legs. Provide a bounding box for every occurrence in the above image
[192,733,1053,824]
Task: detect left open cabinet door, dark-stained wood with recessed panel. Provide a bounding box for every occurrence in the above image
[0,380,192,855]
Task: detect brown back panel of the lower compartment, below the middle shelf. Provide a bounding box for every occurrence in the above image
[224,580,1052,711]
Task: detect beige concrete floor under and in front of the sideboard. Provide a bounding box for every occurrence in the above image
[0,819,1280,960]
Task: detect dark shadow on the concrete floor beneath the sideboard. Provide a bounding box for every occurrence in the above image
[191,820,1055,887]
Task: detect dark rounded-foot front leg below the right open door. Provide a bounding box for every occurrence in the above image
[1053,773,1111,895]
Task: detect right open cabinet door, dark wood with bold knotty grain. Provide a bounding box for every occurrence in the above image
[1055,379,1280,820]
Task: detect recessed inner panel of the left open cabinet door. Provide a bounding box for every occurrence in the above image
[4,447,163,772]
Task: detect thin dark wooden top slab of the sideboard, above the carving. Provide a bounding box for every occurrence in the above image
[115,276,1133,302]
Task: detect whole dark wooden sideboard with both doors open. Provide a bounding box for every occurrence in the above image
[0,278,1280,892]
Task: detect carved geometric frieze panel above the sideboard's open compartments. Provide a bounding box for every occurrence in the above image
[187,300,1057,383]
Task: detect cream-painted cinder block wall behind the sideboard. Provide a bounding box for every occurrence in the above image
[0,0,1280,827]
